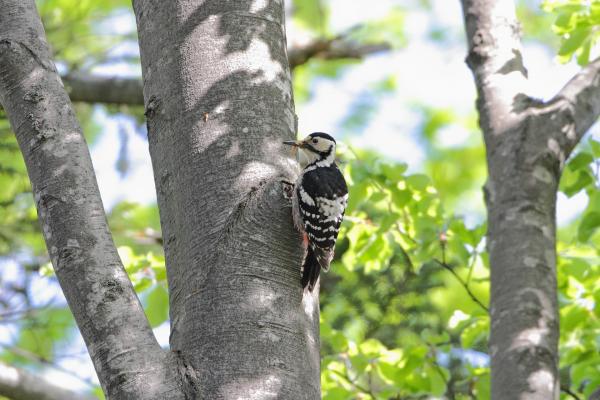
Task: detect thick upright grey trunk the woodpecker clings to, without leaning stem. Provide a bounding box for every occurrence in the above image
[133,0,320,399]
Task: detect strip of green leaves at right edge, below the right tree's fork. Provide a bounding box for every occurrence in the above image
[558,138,600,398]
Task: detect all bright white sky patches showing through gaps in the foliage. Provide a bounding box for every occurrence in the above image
[0,0,587,390]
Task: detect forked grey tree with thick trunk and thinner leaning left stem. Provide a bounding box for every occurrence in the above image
[0,0,320,400]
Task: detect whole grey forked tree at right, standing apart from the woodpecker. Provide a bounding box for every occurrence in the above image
[462,0,600,400]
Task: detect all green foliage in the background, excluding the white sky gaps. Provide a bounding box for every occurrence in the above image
[0,0,600,400]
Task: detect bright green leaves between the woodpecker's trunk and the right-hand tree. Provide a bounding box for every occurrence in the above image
[321,151,489,399]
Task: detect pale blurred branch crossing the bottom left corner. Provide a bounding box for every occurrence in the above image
[0,362,96,400]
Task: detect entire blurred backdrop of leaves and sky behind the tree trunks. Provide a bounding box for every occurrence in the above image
[0,0,600,399]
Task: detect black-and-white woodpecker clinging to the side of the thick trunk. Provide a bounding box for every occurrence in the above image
[283,132,348,292]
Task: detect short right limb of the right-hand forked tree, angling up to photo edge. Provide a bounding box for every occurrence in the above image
[549,58,600,156]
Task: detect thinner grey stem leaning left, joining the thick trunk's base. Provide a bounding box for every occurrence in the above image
[0,0,179,399]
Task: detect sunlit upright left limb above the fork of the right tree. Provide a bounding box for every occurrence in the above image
[462,0,527,135]
